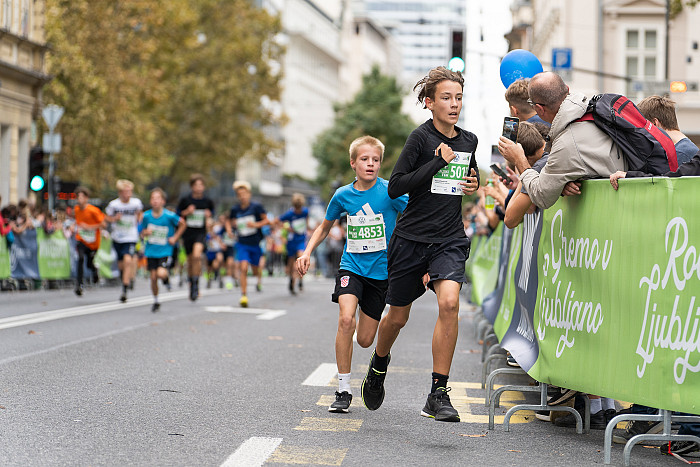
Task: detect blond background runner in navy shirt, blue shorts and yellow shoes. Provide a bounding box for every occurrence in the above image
[226,180,270,307]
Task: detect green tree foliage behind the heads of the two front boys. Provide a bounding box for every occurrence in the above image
[313,66,415,197]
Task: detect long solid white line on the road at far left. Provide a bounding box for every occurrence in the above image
[0,290,223,329]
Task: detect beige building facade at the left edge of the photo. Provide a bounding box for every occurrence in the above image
[0,0,48,205]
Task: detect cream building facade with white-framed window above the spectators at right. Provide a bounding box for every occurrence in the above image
[507,0,700,144]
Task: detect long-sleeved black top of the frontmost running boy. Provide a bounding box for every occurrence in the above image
[389,119,479,243]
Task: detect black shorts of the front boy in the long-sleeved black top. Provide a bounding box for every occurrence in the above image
[386,235,471,306]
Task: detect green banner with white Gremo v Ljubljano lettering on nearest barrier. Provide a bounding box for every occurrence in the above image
[532,178,700,413]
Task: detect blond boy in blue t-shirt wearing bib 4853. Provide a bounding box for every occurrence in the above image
[297,136,408,413]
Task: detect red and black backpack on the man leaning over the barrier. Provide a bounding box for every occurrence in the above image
[575,94,678,175]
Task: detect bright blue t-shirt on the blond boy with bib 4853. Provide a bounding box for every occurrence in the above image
[326,178,408,280]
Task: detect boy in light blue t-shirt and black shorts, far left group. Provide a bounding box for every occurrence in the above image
[139,188,187,313]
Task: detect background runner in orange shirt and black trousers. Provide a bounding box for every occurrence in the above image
[74,186,105,296]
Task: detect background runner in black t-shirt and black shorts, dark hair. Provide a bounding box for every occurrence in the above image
[177,174,214,301]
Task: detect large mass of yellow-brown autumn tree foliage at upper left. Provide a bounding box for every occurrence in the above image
[44,0,283,197]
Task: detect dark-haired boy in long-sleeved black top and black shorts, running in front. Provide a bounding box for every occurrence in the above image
[361,67,479,422]
